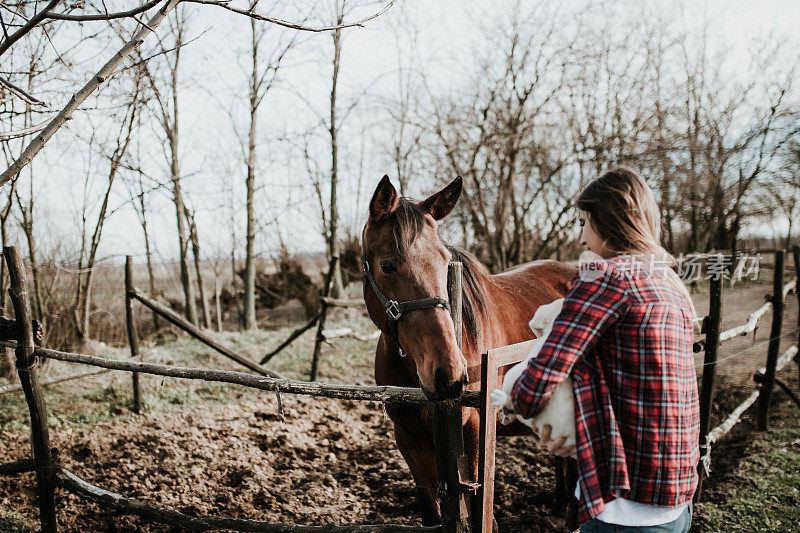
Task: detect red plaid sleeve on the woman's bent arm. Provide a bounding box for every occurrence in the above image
[511,261,626,418]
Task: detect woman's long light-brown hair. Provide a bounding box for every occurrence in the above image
[575,167,697,320]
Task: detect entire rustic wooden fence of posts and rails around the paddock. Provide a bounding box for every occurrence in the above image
[0,246,800,533]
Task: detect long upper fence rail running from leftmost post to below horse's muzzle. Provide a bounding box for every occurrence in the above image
[0,341,479,407]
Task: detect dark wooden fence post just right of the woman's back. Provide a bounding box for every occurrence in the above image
[694,271,723,502]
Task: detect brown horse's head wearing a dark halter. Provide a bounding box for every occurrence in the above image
[363,176,467,400]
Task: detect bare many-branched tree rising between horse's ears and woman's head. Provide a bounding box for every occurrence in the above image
[427,4,575,270]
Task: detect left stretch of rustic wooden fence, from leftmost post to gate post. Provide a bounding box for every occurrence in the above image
[0,247,479,533]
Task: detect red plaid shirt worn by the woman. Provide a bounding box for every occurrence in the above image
[511,256,700,523]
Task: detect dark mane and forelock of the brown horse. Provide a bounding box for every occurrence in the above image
[390,198,490,347]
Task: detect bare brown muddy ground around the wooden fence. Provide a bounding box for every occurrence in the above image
[0,276,798,533]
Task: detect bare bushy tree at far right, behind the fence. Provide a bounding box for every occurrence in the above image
[678,30,800,251]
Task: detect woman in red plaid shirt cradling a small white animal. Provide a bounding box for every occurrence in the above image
[511,167,700,532]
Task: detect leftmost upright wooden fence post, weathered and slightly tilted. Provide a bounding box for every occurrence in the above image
[3,246,58,533]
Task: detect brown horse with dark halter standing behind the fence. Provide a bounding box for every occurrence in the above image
[362,176,577,525]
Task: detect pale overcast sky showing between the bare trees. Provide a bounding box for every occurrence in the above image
[9,0,800,266]
